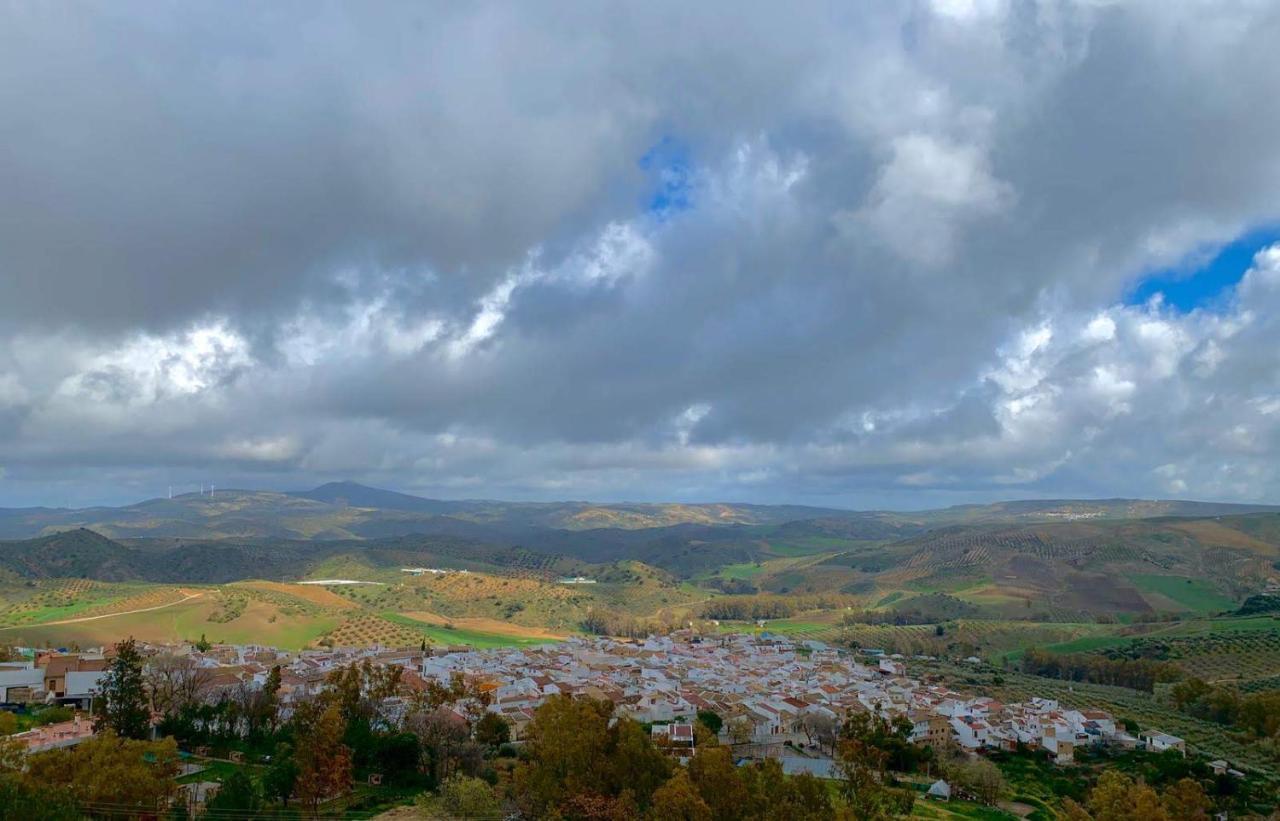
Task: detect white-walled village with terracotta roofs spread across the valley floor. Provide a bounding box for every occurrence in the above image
[0,633,1218,789]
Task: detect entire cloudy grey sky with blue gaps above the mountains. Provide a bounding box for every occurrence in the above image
[0,0,1280,508]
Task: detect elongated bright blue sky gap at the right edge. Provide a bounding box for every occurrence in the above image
[1125,225,1280,314]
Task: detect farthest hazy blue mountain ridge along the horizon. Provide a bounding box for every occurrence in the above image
[0,482,1280,542]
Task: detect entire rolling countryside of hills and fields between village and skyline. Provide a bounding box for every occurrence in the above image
[0,483,1280,685]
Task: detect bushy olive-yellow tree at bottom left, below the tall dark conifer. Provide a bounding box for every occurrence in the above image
[27,729,179,815]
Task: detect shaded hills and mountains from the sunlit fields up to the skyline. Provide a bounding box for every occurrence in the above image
[0,483,1280,620]
